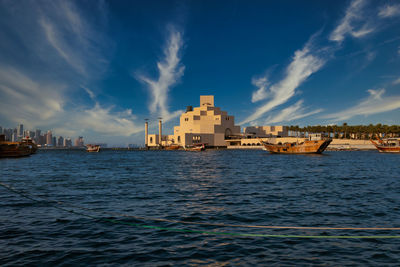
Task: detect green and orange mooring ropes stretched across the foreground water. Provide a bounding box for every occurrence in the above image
[0,182,400,239]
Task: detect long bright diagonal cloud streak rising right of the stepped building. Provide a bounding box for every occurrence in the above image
[240,41,325,124]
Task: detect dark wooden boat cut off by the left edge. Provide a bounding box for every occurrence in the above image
[0,135,37,157]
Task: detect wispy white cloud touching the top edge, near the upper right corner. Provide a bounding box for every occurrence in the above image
[329,0,375,43]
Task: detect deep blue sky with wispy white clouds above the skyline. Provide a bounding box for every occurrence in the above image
[0,0,400,145]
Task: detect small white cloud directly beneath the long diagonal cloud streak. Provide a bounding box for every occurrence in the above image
[265,100,322,124]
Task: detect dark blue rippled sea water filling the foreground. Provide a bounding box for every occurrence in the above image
[0,150,400,266]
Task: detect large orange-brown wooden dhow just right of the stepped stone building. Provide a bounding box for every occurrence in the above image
[260,134,332,154]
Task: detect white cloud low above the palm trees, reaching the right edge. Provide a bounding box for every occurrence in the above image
[321,89,400,121]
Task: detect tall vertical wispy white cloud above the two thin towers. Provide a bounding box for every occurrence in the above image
[137,27,185,120]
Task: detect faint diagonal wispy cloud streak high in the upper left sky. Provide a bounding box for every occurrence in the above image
[38,1,112,79]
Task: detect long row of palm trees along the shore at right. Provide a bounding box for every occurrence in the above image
[288,123,400,139]
